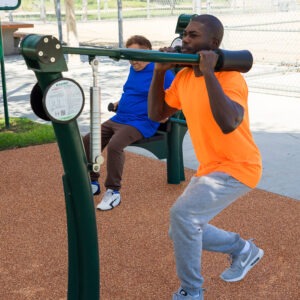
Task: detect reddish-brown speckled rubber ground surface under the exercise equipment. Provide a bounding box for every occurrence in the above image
[0,144,300,300]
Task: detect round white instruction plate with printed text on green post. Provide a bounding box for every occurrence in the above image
[43,78,84,123]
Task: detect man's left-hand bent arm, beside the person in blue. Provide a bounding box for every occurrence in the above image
[148,67,177,122]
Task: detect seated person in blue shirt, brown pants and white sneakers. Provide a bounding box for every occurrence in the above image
[83,35,174,210]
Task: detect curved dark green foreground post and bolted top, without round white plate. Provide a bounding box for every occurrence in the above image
[21,35,100,300]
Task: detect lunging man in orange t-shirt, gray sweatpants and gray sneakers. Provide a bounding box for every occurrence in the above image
[148,15,264,300]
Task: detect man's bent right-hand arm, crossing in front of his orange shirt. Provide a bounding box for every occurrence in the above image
[199,51,244,133]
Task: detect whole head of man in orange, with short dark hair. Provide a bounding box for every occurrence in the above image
[181,14,224,53]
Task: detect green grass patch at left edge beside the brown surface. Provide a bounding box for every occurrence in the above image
[0,118,56,151]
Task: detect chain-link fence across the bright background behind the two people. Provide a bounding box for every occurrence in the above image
[2,0,300,97]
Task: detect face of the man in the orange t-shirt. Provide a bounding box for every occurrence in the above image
[181,21,216,54]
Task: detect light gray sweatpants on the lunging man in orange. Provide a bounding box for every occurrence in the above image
[170,172,250,291]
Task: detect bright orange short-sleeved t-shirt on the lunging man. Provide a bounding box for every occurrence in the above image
[165,68,262,188]
